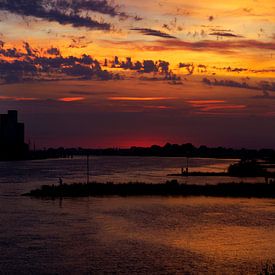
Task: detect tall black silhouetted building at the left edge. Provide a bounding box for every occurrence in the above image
[0,110,28,160]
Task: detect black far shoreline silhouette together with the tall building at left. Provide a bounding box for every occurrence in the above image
[0,110,275,162]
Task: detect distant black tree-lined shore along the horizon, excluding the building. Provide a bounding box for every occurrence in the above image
[29,143,275,161]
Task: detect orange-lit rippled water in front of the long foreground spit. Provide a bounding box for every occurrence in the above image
[0,197,275,274]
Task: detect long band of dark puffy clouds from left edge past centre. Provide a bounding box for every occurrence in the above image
[0,42,183,83]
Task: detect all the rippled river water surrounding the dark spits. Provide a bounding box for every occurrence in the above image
[0,157,275,274]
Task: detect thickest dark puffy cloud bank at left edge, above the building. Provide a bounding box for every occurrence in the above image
[0,42,114,83]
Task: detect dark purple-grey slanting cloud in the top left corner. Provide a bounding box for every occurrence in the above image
[0,0,113,30]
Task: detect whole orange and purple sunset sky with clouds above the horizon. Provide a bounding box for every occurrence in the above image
[0,0,275,148]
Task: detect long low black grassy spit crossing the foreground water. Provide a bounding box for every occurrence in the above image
[23,180,275,198]
